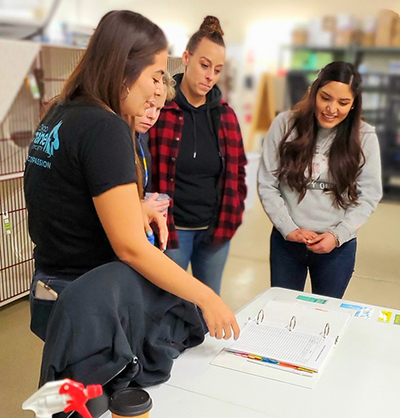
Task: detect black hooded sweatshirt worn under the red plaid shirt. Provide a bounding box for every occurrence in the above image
[174,74,222,228]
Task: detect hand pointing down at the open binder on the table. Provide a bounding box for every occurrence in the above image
[199,289,240,340]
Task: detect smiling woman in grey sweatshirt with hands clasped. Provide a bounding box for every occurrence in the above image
[258,62,382,298]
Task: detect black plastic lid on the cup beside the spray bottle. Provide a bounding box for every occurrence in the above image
[108,388,153,417]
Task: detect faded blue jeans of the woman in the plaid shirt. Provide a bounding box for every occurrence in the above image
[165,229,230,294]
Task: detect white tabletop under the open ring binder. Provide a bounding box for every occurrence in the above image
[103,288,400,418]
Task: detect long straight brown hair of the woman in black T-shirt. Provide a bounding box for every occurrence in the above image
[50,10,167,198]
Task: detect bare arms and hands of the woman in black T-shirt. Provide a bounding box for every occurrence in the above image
[93,183,240,339]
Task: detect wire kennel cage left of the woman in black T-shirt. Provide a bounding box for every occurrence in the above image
[0,41,84,306]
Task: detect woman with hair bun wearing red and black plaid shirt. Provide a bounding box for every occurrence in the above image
[149,16,246,293]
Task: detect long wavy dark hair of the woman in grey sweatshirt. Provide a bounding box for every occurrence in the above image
[276,61,365,209]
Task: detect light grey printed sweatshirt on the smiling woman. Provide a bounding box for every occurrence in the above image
[258,111,382,244]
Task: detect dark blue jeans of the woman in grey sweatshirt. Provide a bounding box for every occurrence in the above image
[270,228,357,299]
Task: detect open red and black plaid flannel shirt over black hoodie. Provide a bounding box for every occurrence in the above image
[149,101,247,248]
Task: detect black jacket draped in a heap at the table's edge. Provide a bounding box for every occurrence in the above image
[40,261,205,389]
